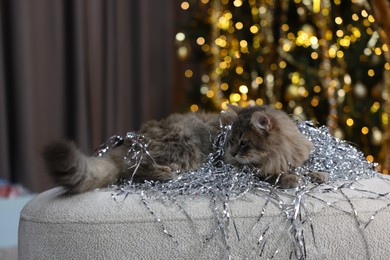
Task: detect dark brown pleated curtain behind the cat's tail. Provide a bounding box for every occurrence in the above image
[0,0,175,191]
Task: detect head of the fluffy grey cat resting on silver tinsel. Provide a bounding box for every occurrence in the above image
[224,106,313,175]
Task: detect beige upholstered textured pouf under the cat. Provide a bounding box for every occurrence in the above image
[19,175,390,260]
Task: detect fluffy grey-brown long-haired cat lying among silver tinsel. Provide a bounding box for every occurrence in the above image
[43,105,327,193]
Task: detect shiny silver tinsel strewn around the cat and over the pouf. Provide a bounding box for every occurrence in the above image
[96,122,377,259]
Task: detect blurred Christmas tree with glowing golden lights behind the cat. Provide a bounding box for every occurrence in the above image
[176,0,390,172]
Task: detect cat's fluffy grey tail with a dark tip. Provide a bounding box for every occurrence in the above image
[43,141,119,193]
